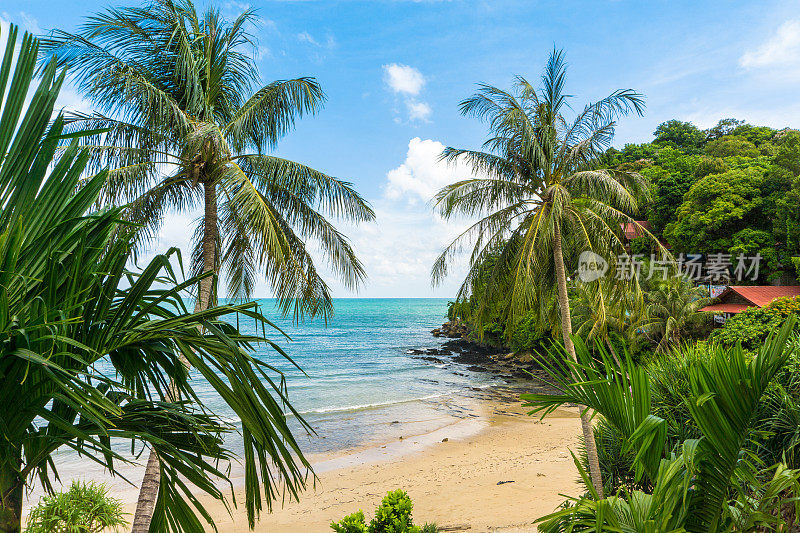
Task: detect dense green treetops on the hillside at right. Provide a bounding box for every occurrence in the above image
[604,119,800,283]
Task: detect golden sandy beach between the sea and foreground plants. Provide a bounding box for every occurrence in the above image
[209,388,581,533]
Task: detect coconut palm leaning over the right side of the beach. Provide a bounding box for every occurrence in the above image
[432,50,644,492]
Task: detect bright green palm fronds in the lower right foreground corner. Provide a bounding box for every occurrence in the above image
[524,320,800,532]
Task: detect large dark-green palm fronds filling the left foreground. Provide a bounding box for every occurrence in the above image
[0,26,309,533]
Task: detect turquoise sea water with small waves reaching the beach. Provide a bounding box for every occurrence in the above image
[206,298,498,454]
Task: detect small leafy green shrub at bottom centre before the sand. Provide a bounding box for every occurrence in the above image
[331,489,438,533]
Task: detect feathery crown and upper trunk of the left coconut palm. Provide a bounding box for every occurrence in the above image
[37,0,374,317]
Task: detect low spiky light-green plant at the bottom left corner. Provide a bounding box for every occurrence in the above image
[25,481,127,533]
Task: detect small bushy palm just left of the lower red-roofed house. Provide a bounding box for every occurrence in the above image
[644,275,709,352]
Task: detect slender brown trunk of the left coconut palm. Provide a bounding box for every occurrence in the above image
[131,182,219,533]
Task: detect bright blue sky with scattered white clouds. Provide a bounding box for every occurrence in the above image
[0,0,800,297]
